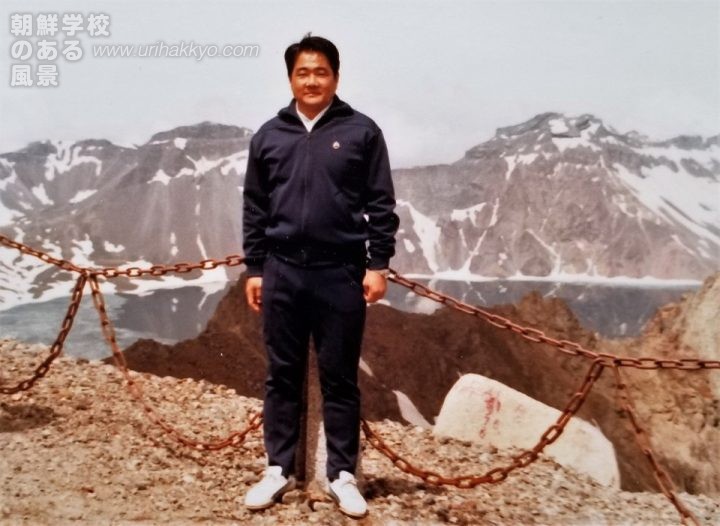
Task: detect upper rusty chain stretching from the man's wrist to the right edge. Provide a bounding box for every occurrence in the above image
[388,269,720,371]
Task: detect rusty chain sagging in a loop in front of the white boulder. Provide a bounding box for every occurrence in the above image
[361,359,605,489]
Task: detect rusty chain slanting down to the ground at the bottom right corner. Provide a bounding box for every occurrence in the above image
[612,367,700,526]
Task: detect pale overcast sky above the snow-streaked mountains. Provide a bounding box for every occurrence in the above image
[0,0,720,167]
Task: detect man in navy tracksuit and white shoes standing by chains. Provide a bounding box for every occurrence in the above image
[243,34,398,517]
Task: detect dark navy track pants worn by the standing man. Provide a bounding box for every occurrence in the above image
[262,255,366,480]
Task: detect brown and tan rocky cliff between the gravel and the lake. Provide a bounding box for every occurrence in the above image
[119,275,720,495]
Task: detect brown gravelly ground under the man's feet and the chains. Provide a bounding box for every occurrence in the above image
[0,340,720,525]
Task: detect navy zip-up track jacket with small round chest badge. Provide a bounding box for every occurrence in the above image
[243,96,399,276]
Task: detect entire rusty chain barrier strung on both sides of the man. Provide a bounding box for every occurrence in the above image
[0,234,720,525]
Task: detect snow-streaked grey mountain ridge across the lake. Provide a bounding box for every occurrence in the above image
[0,112,720,305]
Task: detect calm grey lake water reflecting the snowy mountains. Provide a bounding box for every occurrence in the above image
[0,280,698,359]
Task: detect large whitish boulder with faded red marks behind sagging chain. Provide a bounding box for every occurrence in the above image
[433,374,620,488]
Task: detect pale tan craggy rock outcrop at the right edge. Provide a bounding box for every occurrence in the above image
[599,274,720,495]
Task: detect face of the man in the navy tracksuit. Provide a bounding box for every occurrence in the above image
[290,51,339,119]
